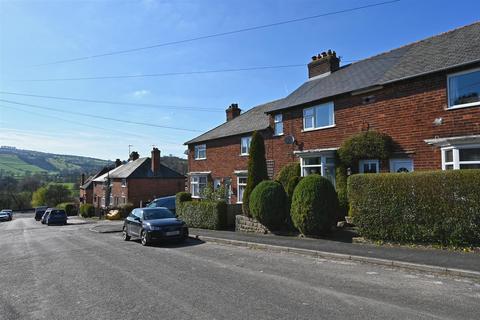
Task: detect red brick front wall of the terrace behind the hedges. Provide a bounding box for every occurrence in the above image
[188,64,480,195]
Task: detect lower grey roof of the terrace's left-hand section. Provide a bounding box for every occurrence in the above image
[185,100,281,144]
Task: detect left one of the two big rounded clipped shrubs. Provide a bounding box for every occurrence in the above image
[249,181,287,230]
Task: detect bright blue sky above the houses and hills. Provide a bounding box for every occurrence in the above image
[0,0,480,159]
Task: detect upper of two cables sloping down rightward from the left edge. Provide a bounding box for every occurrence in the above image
[0,91,225,112]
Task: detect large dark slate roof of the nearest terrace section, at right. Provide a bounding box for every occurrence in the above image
[270,22,480,112]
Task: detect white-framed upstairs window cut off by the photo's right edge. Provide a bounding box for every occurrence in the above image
[448,69,480,108]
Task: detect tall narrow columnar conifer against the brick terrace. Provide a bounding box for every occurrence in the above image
[242,131,268,216]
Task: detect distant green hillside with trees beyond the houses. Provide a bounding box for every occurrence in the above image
[0,146,187,177]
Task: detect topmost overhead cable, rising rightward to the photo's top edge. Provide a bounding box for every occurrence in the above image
[36,0,401,66]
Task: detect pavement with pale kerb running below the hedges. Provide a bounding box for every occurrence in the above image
[89,221,480,279]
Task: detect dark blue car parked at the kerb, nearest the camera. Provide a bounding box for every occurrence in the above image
[123,208,188,246]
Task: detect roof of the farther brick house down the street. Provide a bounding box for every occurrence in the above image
[93,158,184,182]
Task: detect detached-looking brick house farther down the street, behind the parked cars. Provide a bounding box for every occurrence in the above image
[92,148,185,208]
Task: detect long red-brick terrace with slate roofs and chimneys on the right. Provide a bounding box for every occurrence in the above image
[185,23,480,203]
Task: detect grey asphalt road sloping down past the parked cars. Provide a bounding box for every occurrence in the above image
[0,214,480,320]
